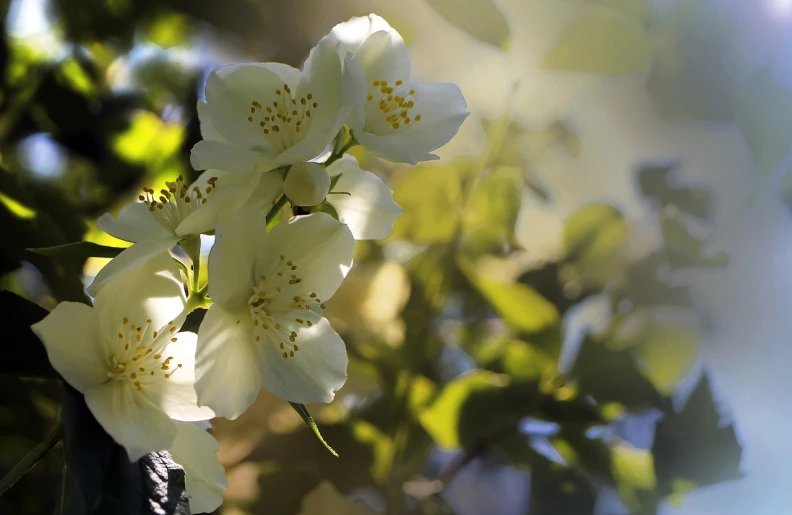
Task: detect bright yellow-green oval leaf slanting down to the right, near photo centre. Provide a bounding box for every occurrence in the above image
[476,279,560,333]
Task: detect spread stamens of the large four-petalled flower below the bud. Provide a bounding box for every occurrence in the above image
[248,256,325,359]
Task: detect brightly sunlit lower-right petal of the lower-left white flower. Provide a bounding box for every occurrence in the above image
[144,332,214,422]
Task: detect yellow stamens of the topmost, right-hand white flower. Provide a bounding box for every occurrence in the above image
[363,80,421,134]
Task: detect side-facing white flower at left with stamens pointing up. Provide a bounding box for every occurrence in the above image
[88,170,280,297]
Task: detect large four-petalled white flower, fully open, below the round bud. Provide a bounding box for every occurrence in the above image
[196,208,355,419]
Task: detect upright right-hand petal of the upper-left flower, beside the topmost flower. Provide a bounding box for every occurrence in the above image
[275,41,344,165]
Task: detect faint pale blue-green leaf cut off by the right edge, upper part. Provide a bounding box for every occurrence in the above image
[735,68,792,172]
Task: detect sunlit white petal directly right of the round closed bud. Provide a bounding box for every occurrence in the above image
[327,155,402,240]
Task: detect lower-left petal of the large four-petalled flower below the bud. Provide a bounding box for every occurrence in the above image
[195,304,261,419]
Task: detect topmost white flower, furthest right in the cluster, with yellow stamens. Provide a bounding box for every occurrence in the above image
[325,14,469,164]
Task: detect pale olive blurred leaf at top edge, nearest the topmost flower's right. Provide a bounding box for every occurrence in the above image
[426,0,510,48]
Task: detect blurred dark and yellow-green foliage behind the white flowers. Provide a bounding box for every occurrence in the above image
[0,0,748,515]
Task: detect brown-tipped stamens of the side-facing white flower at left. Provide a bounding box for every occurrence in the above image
[138,175,217,233]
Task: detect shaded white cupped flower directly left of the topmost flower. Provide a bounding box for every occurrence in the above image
[191,41,352,172]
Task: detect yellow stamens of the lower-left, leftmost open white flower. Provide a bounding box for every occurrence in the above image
[107,317,182,392]
